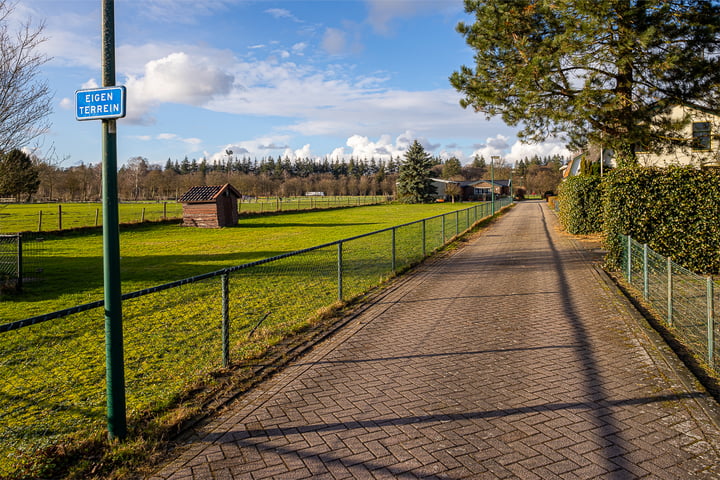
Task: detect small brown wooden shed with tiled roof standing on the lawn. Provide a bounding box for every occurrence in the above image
[178,183,240,228]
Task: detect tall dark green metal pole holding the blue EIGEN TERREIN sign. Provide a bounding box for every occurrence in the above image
[102,0,127,440]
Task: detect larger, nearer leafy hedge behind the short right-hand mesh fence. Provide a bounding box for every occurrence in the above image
[603,166,720,274]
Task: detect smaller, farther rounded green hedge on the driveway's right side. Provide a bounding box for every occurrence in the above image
[559,175,602,235]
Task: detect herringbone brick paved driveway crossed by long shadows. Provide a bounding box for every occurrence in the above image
[151,202,720,479]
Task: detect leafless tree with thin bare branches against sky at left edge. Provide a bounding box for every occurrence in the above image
[0,0,52,152]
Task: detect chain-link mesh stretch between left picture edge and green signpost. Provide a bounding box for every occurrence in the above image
[0,309,105,470]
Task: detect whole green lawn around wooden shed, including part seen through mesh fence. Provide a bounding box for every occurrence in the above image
[0,204,504,478]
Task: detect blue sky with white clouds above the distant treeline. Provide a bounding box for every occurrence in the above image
[13,0,569,167]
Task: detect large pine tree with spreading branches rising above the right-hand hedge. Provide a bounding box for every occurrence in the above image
[450,0,720,165]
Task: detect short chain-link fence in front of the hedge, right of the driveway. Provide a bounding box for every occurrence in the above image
[622,236,720,373]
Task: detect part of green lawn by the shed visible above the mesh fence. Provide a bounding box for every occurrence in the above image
[0,203,480,323]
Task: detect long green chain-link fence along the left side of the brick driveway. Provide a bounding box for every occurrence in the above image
[0,198,510,477]
